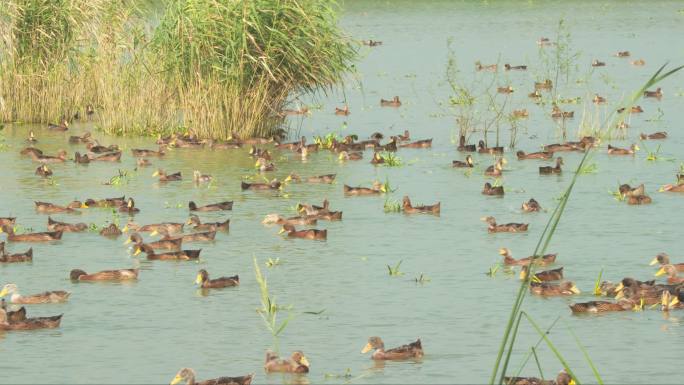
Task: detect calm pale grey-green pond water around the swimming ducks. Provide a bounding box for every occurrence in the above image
[0,1,684,384]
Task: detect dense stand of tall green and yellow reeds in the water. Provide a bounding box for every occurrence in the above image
[0,0,356,139]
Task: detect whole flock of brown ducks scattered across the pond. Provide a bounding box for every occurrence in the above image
[0,36,684,384]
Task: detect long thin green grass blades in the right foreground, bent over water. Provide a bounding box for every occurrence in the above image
[489,64,684,384]
